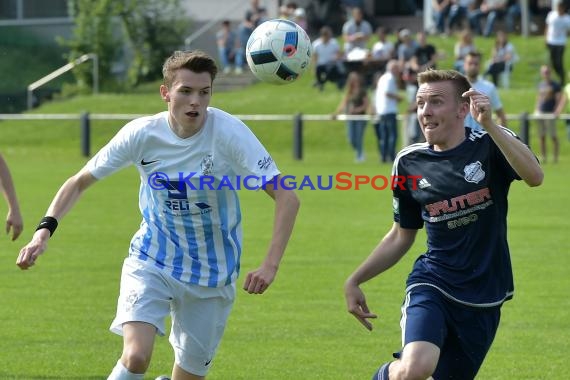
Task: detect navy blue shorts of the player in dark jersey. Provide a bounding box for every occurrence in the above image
[400,286,501,380]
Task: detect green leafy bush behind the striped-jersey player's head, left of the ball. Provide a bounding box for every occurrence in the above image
[60,0,187,93]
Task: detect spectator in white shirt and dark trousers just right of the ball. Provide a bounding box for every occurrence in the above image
[312,26,345,91]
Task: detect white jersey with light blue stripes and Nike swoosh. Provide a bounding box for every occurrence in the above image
[86,107,279,287]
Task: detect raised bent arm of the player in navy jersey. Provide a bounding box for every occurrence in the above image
[463,89,544,186]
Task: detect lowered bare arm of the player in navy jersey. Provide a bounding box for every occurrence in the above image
[344,222,418,330]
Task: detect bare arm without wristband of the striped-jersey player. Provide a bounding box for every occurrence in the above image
[243,177,300,294]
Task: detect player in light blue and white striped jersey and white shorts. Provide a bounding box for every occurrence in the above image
[17,51,299,380]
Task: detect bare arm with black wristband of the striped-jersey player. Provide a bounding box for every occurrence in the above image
[16,169,97,269]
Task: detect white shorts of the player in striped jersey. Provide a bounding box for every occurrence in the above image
[110,257,235,376]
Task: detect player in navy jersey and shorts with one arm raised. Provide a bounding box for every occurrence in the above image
[345,70,543,380]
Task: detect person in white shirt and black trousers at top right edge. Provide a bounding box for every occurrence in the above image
[544,1,570,86]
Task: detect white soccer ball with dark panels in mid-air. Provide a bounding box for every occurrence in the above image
[245,19,313,84]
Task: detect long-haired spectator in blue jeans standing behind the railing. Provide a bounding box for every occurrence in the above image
[334,71,370,162]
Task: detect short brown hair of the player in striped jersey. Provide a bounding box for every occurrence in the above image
[162,50,218,87]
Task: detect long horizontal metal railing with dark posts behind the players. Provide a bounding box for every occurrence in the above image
[0,112,560,160]
